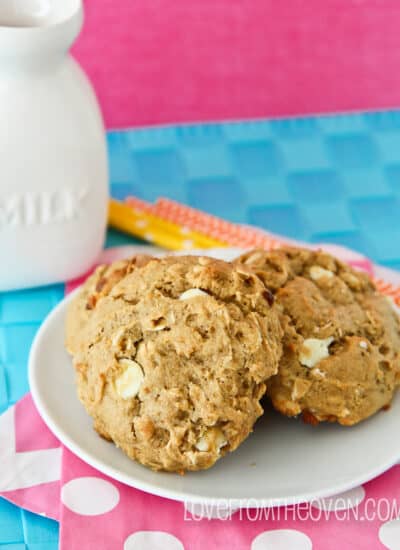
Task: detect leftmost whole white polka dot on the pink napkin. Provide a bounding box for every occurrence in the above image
[61,477,119,516]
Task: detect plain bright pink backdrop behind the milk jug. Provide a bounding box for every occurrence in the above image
[74,0,400,127]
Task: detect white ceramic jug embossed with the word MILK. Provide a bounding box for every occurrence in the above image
[0,0,108,291]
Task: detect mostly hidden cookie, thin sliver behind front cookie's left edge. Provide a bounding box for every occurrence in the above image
[65,254,152,354]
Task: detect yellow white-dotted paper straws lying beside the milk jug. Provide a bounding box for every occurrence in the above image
[108,199,227,250]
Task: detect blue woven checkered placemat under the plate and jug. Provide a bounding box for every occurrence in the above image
[0,111,400,550]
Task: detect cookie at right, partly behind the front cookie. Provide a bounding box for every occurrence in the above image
[236,248,400,426]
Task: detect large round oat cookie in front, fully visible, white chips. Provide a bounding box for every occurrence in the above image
[65,256,282,472]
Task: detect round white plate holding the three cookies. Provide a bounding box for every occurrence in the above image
[29,250,400,508]
